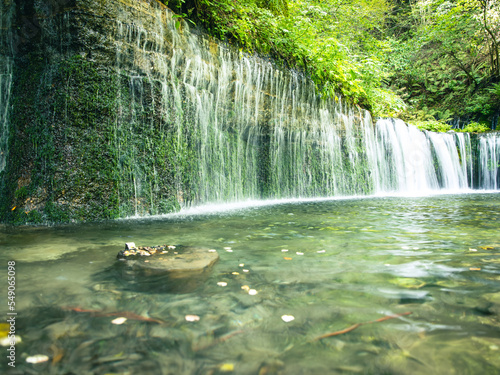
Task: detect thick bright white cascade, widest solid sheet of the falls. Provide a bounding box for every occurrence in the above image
[372,119,473,194]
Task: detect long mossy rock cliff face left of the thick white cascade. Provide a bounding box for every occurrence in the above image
[0,0,371,223]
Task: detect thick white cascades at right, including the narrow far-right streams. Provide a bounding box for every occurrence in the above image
[371,119,500,194]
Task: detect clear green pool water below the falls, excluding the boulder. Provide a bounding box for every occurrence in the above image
[0,194,500,375]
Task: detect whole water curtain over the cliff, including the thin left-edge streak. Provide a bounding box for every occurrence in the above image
[0,0,500,217]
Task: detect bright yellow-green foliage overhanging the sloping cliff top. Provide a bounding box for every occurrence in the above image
[162,0,401,115]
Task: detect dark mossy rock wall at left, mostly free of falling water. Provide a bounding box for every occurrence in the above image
[1,0,194,223]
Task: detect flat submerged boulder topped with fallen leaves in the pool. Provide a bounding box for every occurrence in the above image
[117,242,219,293]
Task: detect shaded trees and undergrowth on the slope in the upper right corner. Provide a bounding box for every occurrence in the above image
[388,0,500,125]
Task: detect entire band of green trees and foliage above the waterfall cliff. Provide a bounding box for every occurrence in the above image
[165,0,500,129]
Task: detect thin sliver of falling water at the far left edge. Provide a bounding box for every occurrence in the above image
[0,1,14,172]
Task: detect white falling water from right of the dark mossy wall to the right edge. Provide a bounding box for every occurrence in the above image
[106,2,499,216]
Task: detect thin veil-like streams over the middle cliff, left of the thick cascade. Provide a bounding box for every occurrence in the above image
[110,8,373,214]
